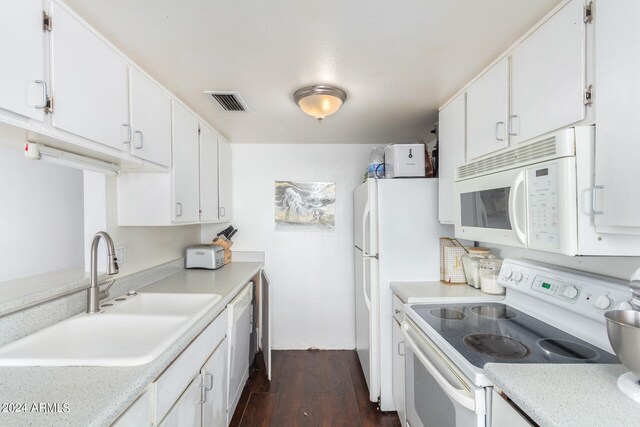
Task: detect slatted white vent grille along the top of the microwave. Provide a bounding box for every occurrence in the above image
[454,135,559,181]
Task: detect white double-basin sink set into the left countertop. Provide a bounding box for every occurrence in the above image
[0,293,222,366]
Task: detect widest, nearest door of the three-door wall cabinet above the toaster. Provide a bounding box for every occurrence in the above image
[172,101,200,222]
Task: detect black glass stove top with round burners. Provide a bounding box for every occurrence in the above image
[411,302,620,368]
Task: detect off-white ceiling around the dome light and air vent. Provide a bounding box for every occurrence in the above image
[66,0,560,144]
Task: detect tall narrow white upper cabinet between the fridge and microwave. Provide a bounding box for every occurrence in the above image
[438,93,467,224]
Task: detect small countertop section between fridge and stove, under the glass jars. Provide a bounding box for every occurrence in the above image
[391,282,504,304]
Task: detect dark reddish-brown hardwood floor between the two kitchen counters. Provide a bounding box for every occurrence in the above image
[231,350,400,427]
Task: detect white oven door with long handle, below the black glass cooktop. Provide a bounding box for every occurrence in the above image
[402,319,486,427]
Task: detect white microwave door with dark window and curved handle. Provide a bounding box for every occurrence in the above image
[454,168,527,248]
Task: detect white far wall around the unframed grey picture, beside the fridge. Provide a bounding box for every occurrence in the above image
[202,144,373,349]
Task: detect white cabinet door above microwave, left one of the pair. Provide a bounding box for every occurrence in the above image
[467,58,509,161]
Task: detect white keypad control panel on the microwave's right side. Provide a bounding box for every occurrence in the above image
[527,163,560,249]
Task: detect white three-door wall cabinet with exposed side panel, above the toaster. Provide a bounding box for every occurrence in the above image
[118,101,232,226]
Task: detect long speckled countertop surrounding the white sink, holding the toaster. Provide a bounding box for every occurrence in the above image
[0,262,263,427]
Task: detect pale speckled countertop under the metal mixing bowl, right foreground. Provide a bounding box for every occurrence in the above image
[484,363,640,427]
